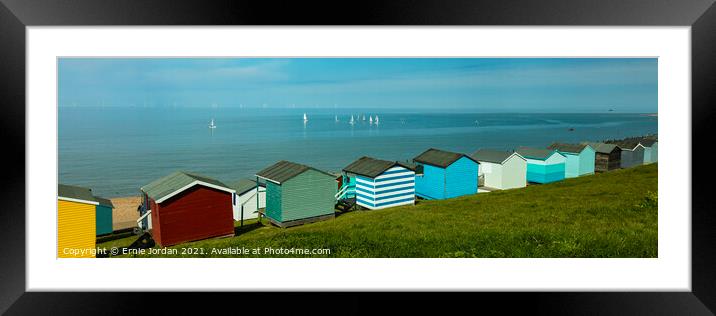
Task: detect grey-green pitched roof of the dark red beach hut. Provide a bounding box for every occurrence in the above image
[141,171,233,203]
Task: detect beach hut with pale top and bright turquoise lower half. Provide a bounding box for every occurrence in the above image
[517,147,567,183]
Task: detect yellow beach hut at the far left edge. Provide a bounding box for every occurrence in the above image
[57,184,99,258]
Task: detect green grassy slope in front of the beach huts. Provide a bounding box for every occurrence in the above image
[98,164,658,258]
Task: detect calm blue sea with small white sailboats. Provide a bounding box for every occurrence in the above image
[58,106,658,198]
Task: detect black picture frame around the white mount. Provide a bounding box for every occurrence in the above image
[0,0,716,315]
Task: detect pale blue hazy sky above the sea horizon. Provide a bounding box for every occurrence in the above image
[58,58,658,113]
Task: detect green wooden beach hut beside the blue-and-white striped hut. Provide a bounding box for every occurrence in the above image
[256,161,337,227]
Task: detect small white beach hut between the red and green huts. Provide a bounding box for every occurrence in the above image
[229,179,266,221]
